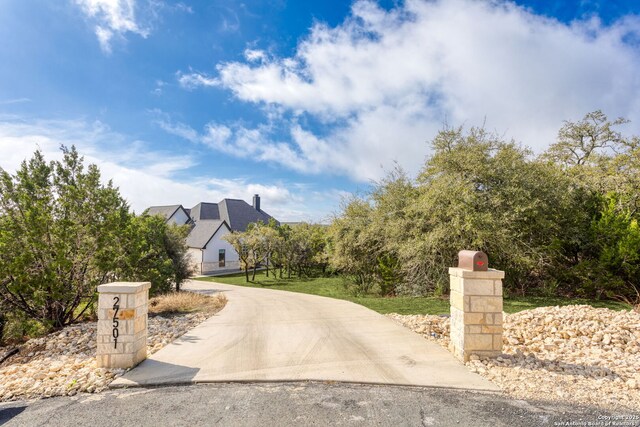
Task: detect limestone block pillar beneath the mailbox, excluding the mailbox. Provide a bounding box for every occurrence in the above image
[449,267,504,362]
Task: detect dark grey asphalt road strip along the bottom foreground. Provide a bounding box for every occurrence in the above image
[0,382,640,427]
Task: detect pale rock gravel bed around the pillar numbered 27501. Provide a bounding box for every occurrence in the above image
[0,312,213,402]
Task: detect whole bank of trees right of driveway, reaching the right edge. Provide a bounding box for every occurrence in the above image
[330,111,640,298]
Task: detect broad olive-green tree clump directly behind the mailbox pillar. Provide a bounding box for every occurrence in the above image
[332,128,574,295]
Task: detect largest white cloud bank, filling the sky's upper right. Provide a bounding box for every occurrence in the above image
[181,0,640,181]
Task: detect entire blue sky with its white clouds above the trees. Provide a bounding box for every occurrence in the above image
[0,0,640,221]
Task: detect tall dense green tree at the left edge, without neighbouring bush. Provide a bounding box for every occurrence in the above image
[0,147,128,327]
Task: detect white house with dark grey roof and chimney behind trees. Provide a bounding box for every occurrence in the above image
[145,194,273,274]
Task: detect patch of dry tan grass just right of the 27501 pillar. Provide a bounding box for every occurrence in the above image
[149,291,227,314]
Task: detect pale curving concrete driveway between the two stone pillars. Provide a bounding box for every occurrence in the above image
[112,281,498,391]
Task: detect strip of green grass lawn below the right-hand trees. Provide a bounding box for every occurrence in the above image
[197,272,631,314]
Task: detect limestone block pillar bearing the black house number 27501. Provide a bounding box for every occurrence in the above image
[97,282,151,368]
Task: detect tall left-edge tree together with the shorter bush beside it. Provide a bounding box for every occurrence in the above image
[0,147,195,328]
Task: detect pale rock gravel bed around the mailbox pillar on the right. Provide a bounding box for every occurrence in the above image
[388,305,640,410]
